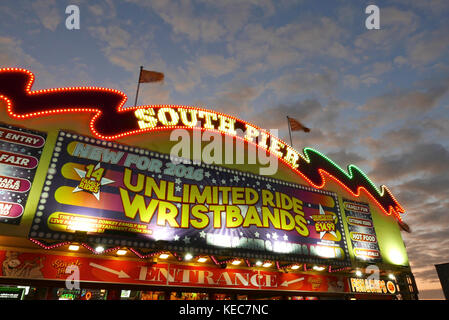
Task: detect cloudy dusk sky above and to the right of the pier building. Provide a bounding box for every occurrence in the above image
[0,0,449,299]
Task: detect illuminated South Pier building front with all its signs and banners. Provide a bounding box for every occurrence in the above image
[0,68,418,300]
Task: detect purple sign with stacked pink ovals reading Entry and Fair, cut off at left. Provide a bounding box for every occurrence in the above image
[0,123,46,225]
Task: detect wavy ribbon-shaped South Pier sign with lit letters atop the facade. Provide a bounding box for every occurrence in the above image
[0,68,404,222]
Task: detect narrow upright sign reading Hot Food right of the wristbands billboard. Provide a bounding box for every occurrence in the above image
[343,199,382,262]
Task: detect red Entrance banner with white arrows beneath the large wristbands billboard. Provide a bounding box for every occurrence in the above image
[0,250,349,293]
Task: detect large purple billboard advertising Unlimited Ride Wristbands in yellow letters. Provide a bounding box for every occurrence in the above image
[30,132,349,264]
